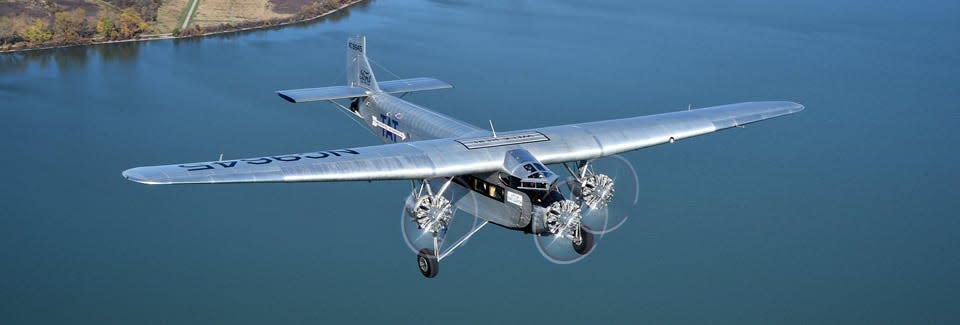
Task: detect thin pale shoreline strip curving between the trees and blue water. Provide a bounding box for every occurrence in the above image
[0,0,366,54]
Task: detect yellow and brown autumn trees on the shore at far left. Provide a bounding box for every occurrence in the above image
[0,7,148,51]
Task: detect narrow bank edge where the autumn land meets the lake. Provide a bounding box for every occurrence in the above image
[0,0,366,53]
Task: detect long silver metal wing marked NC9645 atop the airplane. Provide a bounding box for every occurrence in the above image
[123,102,803,184]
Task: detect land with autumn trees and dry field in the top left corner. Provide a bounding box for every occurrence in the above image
[0,0,360,51]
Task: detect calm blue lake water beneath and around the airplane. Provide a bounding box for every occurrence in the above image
[0,0,960,324]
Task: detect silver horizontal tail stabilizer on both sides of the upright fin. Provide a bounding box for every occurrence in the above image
[277,78,453,103]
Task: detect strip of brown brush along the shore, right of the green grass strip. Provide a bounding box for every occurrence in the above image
[173,0,356,37]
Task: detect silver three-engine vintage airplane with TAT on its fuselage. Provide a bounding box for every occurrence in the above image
[123,35,804,278]
